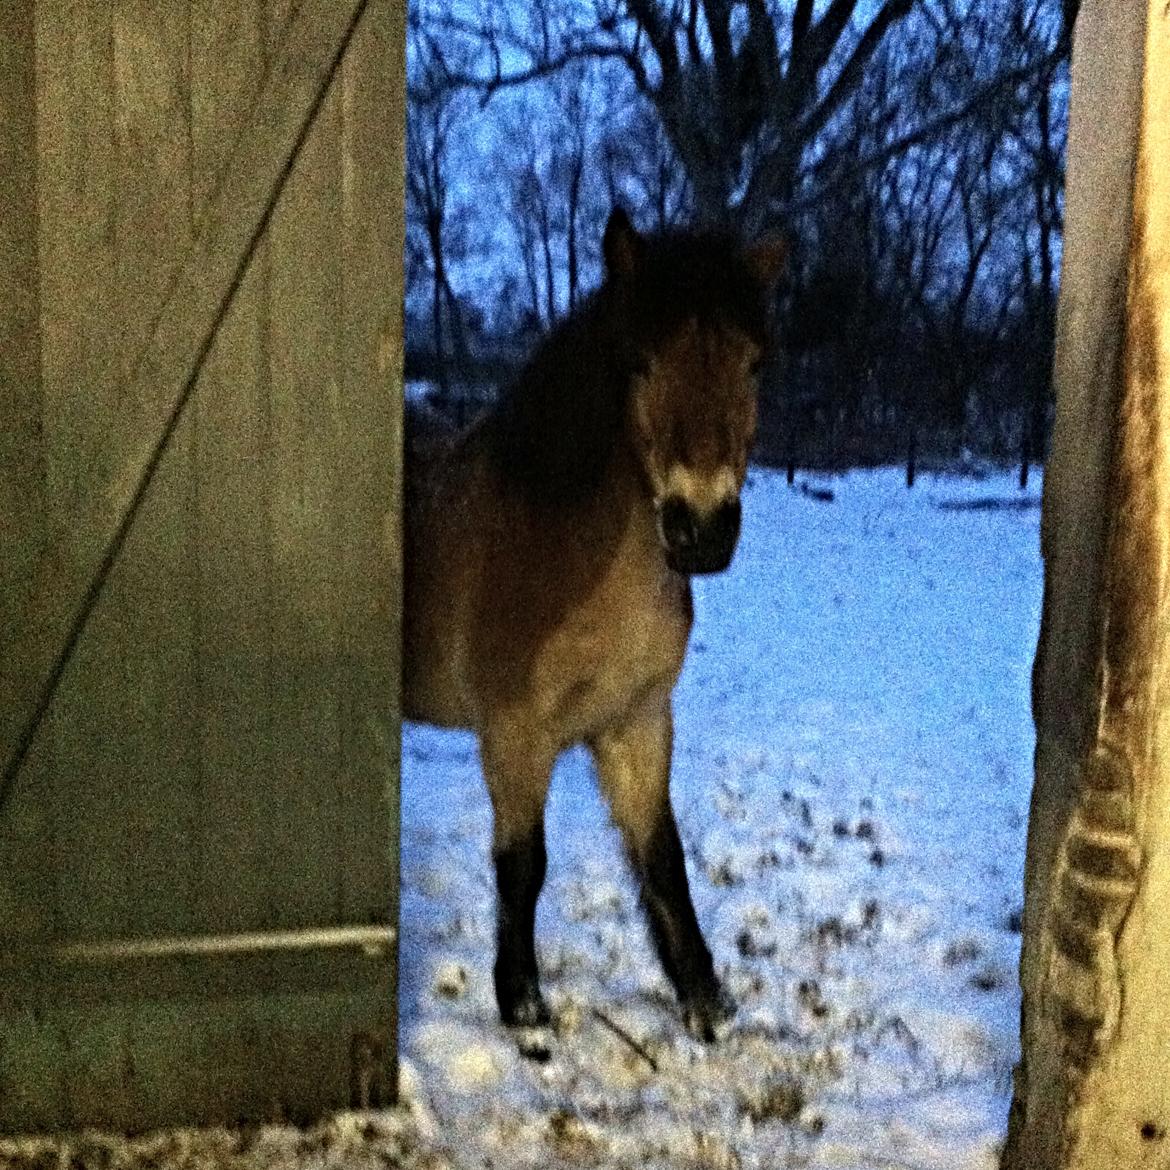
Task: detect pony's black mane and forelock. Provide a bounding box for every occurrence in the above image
[489,232,768,504]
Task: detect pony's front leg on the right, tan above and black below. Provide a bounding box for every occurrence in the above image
[590,694,736,1041]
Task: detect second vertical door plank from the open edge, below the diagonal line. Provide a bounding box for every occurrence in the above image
[264,75,344,927]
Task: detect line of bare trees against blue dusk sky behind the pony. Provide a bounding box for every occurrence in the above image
[407,0,1076,477]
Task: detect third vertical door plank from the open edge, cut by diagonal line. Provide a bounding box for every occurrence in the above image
[191,0,280,931]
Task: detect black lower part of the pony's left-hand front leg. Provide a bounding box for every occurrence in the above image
[495,819,549,1025]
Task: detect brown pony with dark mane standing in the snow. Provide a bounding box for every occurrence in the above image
[404,211,783,1040]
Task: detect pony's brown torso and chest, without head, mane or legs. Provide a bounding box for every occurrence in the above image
[404,419,690,752]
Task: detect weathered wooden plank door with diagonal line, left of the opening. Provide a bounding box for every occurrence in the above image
[0,0,405,1130]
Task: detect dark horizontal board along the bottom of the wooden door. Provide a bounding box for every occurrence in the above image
[0,961,390,1134]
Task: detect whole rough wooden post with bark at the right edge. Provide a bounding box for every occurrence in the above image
[1003,0,1170,1170]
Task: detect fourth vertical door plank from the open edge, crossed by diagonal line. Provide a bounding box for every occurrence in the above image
[105,0,200,936]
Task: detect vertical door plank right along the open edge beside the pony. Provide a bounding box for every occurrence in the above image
[337,0,406,1093]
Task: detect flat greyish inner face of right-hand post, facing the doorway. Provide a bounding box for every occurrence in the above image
[1024,0,1144,1015]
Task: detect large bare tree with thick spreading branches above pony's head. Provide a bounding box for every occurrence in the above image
[413,0,921,228]
